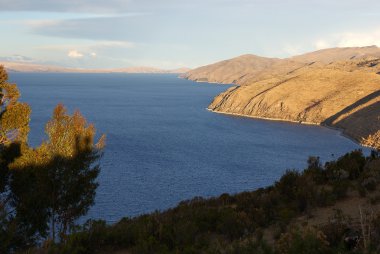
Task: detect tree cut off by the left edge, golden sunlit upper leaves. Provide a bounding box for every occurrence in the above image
[0,66,31,253]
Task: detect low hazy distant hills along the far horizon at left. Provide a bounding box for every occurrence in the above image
[0,61,190,73]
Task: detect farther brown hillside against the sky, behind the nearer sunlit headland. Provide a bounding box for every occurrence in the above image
[181,46,380,85]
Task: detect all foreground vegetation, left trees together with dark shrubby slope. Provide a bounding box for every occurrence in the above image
[0,68,380,254]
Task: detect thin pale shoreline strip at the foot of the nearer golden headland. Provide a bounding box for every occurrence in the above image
[206,108,375,149]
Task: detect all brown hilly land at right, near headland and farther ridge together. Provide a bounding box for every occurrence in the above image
[184,46,380,147]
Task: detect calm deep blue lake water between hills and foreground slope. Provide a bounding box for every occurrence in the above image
[10,73,366,222]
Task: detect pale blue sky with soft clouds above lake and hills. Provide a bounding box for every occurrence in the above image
[0,0,380,69]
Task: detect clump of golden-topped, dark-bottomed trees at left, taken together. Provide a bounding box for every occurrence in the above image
[0,66,105,253]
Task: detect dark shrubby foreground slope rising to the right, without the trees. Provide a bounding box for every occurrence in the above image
[40,150,380,254]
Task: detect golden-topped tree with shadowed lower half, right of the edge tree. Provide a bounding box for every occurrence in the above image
[41,104,105,239]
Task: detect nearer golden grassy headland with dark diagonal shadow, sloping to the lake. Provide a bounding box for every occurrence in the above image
[209,60,380,146]
